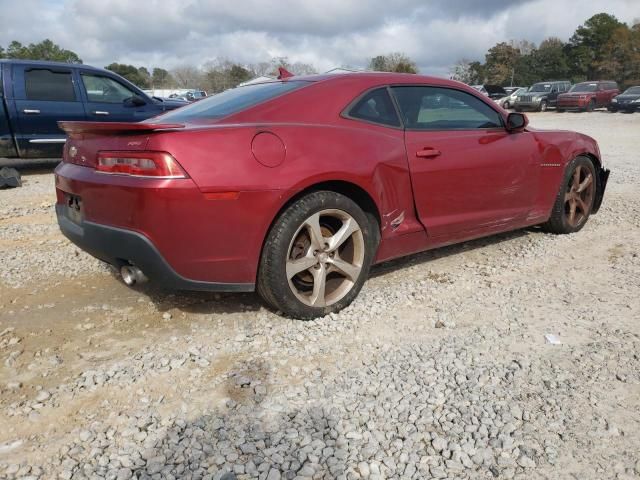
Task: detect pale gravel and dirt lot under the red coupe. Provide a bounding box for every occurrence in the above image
[0,112,640,480]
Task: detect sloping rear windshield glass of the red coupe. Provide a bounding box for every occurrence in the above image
[156,80,309,123]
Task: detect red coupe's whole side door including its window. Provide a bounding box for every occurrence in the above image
[392,86,539,237]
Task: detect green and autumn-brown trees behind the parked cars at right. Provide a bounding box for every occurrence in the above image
[451,13,640,87]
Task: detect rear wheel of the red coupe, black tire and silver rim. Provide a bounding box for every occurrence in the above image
[257,191,379,319]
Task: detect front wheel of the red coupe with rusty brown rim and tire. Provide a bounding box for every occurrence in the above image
[542,156,596,234]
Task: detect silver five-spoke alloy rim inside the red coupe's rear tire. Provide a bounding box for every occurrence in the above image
[286,209,365,307]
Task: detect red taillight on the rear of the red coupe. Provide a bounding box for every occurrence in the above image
[96,152,187,178]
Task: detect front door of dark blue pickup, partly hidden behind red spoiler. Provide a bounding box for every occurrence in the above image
[80,70,160,122]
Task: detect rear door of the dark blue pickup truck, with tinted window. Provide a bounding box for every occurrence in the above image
[13,65,85,158]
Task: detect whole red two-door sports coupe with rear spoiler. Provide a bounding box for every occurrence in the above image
[56,73,609,318]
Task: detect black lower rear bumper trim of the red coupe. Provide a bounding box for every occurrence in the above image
[56,204,254,292]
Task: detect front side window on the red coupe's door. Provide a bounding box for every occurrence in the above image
[392,87,503,130]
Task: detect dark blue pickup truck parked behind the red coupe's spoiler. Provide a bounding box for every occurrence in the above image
[0,60,187,159]
